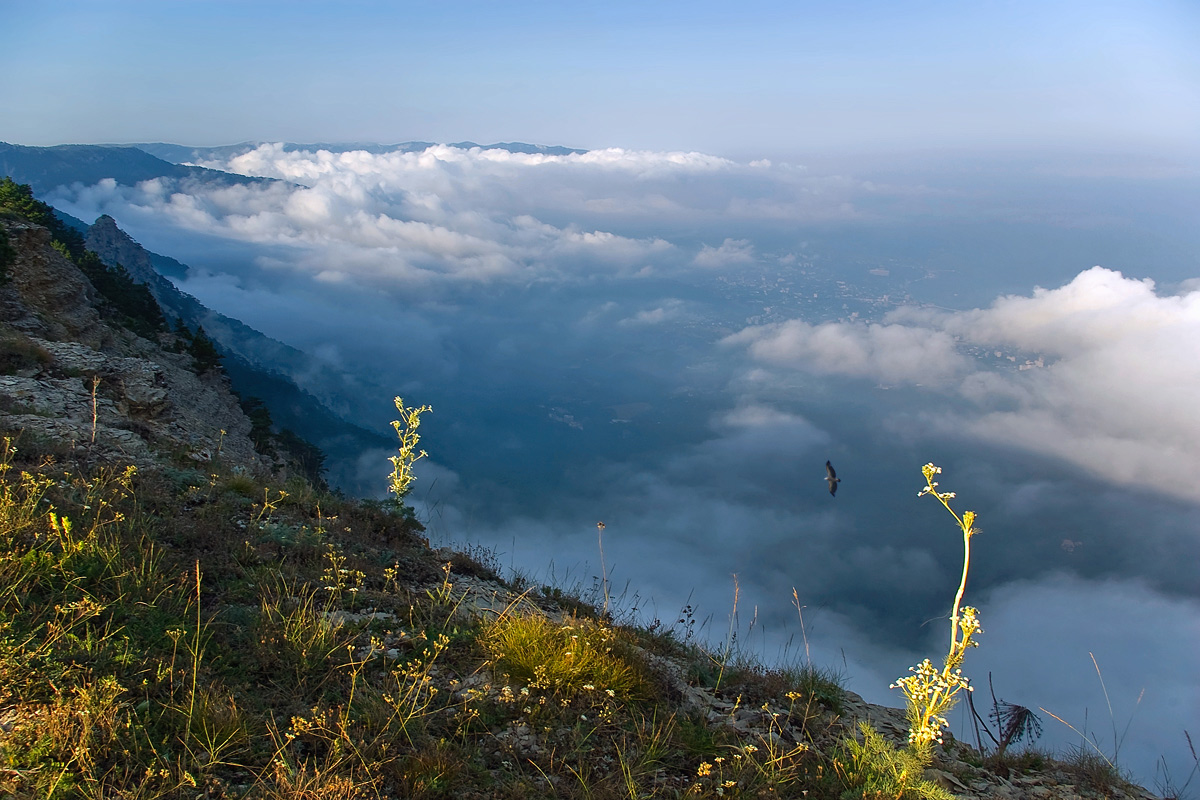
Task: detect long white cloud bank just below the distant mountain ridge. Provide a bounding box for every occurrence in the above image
[50,144,907,293]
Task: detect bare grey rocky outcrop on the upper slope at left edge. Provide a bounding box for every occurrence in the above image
[0,215,264,470]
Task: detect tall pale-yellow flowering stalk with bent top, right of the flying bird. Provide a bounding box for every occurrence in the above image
[892,464,983,754]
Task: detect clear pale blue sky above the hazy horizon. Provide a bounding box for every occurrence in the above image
[0,0,1200,158]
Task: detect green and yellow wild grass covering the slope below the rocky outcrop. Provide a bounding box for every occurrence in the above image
[0,443,1161,800]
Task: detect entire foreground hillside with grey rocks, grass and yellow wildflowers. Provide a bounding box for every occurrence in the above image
[0,182,1166,800]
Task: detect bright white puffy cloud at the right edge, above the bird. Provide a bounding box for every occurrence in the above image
[726,267,1200,500]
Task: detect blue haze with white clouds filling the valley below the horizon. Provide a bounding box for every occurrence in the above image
[48,145,1200,787]
